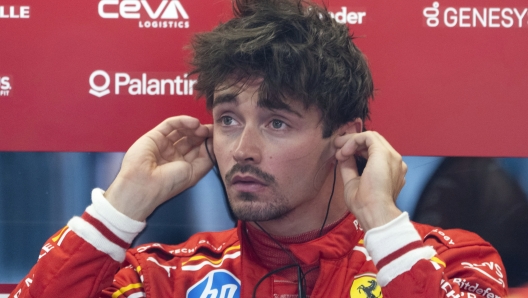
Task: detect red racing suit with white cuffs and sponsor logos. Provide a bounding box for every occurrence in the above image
[9,189,507,298]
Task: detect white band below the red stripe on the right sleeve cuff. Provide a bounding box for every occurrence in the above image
[376,246,436,287]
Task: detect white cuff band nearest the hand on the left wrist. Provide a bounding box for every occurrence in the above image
[86,188,146,243]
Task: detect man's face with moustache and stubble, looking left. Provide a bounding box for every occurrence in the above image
[212,80,334,221]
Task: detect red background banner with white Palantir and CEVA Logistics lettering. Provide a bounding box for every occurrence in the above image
[0,0,528,157]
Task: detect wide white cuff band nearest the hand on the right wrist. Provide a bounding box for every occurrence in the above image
[364,212,422,265]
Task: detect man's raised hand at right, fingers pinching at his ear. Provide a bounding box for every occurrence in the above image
[334,131,407,230]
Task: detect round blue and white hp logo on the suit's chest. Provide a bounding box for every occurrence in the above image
[187,269,240,298]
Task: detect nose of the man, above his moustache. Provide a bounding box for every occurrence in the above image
[233,126,262,164]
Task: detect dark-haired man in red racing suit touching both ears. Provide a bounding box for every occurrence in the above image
[13,0,507,298]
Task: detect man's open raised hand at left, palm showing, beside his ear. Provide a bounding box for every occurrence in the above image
[105,116,213,221]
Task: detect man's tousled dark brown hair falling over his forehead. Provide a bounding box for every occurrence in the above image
[191,0,373,138]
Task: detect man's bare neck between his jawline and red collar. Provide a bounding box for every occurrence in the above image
[252,165,348,237]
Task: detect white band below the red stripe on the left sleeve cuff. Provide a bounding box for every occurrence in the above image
[68,216,126,263]
